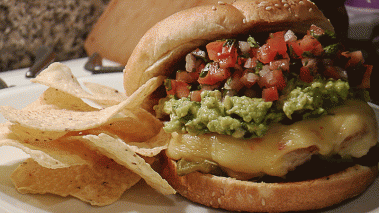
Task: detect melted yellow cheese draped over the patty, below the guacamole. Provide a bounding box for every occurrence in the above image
[166,101,378,176]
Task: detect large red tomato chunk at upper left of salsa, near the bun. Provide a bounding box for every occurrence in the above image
[205,40,238,68]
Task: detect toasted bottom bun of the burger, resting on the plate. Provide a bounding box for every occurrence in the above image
[161,157,378,212]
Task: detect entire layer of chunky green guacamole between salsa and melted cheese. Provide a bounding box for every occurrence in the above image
[155,77,349,138]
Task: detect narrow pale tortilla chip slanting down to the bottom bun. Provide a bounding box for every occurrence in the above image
[83,133,175,194]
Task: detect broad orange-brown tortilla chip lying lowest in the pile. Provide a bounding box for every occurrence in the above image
[11,157,141,206]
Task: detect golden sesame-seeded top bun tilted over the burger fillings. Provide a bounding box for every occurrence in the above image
[124,0,333,95]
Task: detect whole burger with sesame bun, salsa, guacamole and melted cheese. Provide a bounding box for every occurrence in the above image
[124,0,378,212]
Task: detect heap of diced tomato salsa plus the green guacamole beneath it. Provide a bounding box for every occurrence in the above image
[155,25,372,138]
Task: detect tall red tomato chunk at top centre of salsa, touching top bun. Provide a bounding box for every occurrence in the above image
[257,31,287,64]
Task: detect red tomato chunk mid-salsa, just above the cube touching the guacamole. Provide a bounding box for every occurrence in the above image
[258,70,286,90]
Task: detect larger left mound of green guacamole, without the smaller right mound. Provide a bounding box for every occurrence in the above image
[160,90,282,138]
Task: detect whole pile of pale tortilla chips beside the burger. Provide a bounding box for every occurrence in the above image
[0,63,175,206]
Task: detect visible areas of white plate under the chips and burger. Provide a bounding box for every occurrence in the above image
[0,73,379,213]
